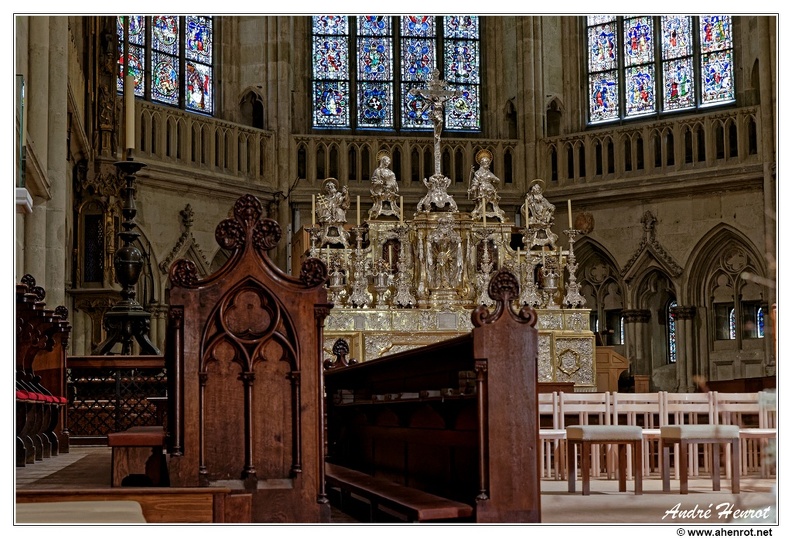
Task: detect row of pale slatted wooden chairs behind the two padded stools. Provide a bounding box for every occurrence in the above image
[539,391,776,479]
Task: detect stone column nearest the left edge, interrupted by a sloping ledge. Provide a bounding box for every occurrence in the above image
[19,16,49,282]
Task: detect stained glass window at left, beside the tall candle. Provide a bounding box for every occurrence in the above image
[116,15,214,114]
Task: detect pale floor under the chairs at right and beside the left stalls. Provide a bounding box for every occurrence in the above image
[16,446,778,526]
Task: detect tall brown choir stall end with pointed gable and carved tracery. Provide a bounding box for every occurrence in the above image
[165,195,332,522]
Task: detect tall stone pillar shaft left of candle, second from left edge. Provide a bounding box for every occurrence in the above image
[44,16,71,306]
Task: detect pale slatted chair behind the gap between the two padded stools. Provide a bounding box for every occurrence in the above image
[611,392,663,477]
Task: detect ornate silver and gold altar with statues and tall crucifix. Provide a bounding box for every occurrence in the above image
[305,73,596,391]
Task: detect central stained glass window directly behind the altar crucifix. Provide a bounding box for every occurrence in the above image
[312,15,481,131]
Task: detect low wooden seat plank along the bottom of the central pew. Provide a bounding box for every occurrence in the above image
[325,464,473,522]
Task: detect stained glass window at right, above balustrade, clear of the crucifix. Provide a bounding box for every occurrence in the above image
[586,15,734,123]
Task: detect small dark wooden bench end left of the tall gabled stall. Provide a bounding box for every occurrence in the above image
[107,426,170,487]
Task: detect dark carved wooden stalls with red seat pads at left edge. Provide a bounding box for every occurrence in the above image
[15,275,71,466]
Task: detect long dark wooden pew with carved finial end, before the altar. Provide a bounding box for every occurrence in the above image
[324,271,541,522]
